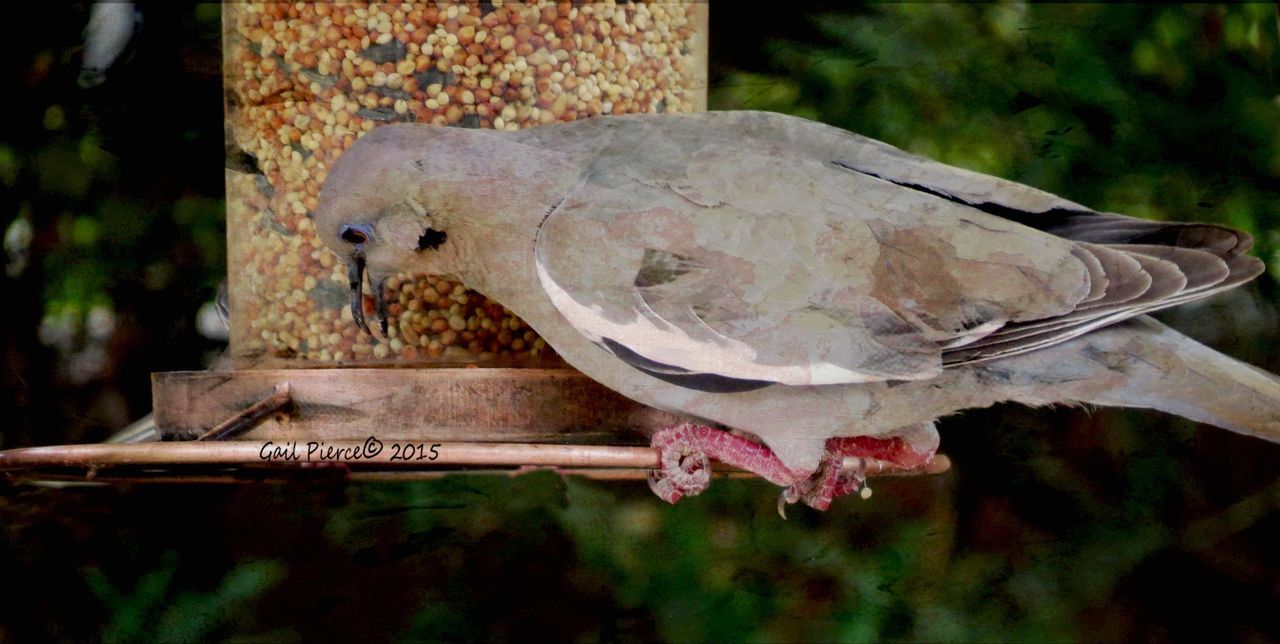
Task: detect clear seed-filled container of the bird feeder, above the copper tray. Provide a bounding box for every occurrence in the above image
[224,3,707,369]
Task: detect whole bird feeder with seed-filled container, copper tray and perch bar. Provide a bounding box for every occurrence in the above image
[0,0,946,491]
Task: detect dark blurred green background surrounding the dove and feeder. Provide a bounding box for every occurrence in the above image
[0,3,1280,641]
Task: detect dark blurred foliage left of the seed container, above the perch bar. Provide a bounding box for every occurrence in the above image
[0,3,227,447]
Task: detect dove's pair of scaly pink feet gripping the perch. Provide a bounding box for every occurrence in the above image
[649,423,933,516]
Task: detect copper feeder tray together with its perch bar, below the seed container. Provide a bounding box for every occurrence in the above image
[0,369,950,483]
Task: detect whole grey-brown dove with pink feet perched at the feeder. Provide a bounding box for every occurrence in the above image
[314,111,1280,511]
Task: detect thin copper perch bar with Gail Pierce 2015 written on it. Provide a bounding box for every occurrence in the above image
[0,439,951,479]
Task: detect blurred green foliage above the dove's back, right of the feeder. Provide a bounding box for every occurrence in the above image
[712,4,1280,284]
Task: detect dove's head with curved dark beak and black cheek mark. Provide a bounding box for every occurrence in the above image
[315,125,481,335]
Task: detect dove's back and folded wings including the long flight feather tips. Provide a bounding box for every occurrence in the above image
[527,113,1263,388]
